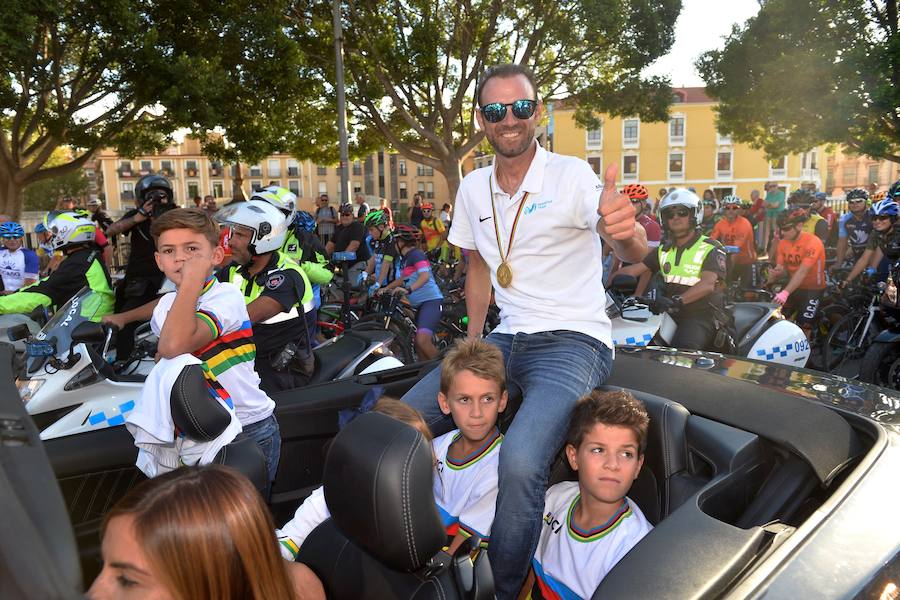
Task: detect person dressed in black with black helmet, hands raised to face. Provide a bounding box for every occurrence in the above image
[106,173,175,360]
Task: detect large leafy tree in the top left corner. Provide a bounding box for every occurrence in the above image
[0,0,336,215]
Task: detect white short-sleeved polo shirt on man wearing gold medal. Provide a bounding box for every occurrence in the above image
[448,145,613,349]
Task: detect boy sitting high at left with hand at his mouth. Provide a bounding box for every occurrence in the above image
[150,208,281,482]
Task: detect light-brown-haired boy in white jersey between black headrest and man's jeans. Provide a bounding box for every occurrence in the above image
[432,338,507,555]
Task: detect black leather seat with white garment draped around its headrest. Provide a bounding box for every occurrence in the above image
[169,365,269,496]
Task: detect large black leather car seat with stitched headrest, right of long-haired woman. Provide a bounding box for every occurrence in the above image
[298,413,493,600]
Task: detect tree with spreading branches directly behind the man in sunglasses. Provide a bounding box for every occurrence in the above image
[293,0,681,202]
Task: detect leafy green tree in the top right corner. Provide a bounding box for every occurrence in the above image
[697,0,900,162]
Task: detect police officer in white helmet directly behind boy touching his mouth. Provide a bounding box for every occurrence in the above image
[216,200,315,394]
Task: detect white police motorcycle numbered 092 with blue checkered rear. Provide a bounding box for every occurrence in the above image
[606,277,811,367]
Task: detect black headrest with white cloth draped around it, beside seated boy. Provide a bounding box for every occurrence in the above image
[169,365,231,442]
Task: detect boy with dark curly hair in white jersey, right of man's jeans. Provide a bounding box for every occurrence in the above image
[519,390,652,600]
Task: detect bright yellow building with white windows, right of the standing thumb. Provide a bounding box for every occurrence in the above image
[546,88,825,199]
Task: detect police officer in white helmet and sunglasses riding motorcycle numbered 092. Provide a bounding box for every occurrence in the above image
[622,188,730,350]
